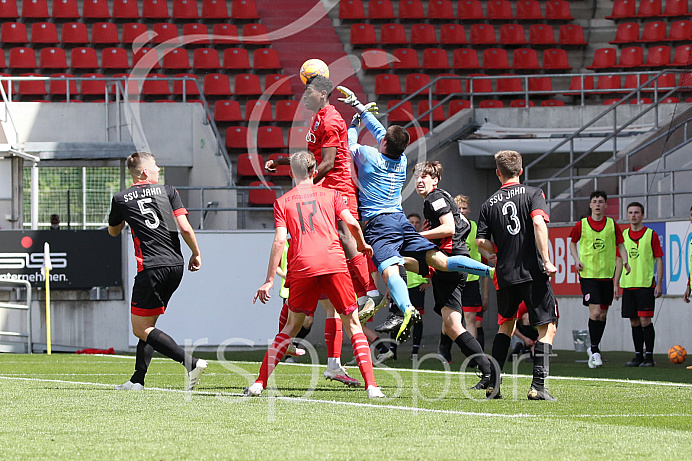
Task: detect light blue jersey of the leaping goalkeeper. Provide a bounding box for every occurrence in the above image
[348,112,408,221]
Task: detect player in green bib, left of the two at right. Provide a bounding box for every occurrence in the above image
[569,190,630,368]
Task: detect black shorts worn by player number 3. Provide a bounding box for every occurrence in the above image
[497,275,557,327]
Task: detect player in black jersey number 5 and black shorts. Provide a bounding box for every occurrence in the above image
[108,152,207,390]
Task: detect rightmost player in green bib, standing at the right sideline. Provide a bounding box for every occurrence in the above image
[615,202,663,367]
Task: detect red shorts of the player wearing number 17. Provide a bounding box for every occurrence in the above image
[288,272,358,315]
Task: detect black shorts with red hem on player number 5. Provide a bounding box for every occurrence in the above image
[130,266,183,317]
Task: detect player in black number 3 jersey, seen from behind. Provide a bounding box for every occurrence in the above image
[476,151,557,400]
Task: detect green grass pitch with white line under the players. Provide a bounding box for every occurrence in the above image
[0,351,692,460]
